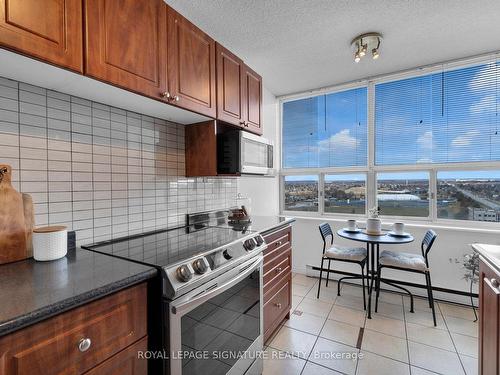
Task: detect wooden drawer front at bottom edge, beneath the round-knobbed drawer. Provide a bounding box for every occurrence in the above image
[85,336,148,375]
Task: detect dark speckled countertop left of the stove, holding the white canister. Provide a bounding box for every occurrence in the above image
[0,248,157,336]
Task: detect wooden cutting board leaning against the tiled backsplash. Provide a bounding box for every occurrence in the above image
[0,164,34,264]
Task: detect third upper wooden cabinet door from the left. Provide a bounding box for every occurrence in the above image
[168,8,216,118]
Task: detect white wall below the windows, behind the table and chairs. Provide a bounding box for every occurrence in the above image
[292,218,500,303]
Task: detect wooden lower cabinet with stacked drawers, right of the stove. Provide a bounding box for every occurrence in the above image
[263,226,292,342]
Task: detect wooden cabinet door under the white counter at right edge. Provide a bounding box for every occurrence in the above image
[479,262,500,375]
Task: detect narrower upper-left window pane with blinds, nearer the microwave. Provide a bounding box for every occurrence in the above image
[282,87,367,168]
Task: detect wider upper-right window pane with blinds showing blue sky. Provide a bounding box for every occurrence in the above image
[375,61,500,165]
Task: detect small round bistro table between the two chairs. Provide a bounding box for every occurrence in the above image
[337,229,414,319]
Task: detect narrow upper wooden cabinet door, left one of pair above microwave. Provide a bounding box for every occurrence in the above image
[216,44,245,126]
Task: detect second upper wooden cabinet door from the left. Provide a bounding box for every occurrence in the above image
[85,0,167,99]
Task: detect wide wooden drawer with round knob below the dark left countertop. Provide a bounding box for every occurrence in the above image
[0,283,147,375]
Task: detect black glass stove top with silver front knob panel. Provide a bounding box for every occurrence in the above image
[82,223,266,298]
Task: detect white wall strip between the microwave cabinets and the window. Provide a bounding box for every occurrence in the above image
[238,88,281,215]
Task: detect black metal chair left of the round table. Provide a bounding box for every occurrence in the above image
[317,223,367,310]
